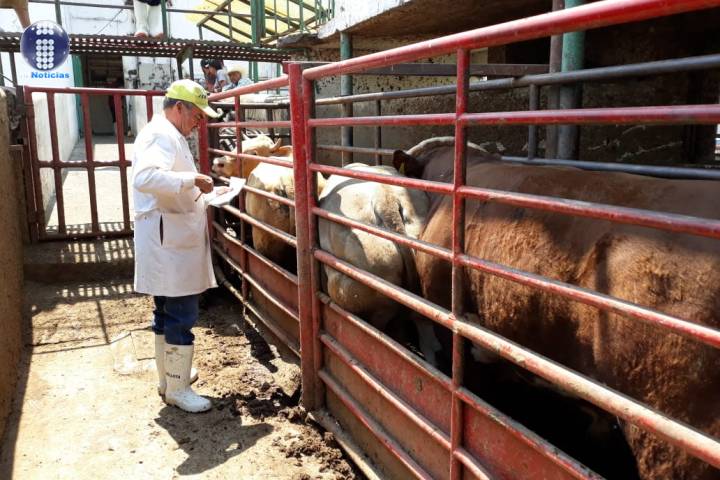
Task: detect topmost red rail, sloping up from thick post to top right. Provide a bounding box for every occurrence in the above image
[303,0,720,80]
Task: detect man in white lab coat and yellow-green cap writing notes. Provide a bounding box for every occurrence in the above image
[132,80,219,412]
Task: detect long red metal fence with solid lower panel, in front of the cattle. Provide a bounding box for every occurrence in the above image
[204,0,720,479]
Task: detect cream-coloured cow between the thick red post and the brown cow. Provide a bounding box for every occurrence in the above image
[318,163,440,364]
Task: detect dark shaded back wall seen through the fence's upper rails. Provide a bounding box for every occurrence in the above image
[300,9,720,165]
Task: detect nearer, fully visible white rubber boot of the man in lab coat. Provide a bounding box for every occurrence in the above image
[165,344,212,413]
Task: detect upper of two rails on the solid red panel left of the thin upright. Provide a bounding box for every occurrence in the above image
[320,333,450,451]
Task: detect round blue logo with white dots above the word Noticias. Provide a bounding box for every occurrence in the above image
[20,20,70,71]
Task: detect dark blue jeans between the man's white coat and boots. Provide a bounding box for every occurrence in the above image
[152,295,200,345]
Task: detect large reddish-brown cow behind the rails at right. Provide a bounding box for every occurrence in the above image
[394,137,720,480]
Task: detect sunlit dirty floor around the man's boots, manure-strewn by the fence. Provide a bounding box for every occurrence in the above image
[0,281,362,480]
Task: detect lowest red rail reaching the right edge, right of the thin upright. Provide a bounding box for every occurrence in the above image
[453,319,720,467]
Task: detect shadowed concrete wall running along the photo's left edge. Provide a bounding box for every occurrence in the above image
[0,91,23,438]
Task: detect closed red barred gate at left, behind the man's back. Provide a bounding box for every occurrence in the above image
[24,87,164,242]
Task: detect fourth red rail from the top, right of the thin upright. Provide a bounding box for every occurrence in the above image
[458,255,720,348]
